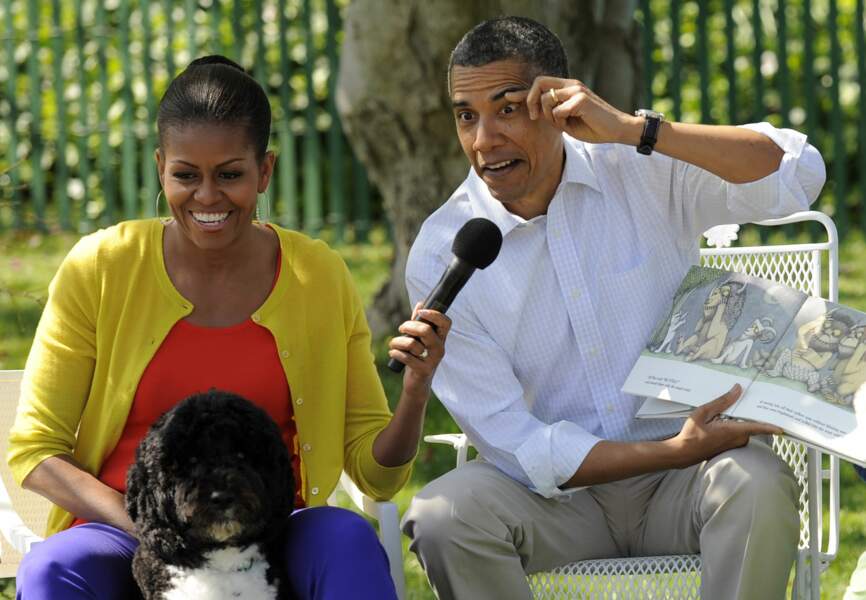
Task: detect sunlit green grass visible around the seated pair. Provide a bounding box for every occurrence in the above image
[0,231,866,600]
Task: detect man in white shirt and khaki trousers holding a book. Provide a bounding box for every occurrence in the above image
[403,17,824,600]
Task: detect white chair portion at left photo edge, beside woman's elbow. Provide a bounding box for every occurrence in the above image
[0,371,51,577]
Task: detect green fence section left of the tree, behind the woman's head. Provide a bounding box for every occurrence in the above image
[0,0,372,240]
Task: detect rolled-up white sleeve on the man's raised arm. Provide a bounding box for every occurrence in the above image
[669,123,826,239]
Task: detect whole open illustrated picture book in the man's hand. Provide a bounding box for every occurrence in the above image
[622,267,866,465]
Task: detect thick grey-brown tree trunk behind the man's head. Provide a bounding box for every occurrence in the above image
[337,0,640,336]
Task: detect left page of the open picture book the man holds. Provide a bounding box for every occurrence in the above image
[622,267,807,416]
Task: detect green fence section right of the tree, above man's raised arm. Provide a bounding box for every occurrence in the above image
[638,0,866,236]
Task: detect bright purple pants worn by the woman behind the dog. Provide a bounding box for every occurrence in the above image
[16,506,397,600]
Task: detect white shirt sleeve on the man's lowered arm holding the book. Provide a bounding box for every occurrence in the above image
[406,237,600,498]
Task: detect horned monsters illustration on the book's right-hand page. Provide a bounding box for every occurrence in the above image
[759,298,866,411]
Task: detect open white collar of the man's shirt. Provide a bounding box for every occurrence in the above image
[457,134,601,237]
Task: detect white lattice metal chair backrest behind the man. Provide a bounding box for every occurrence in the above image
[701,211,839,597]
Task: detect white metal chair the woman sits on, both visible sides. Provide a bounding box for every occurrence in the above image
[0,371,406,600]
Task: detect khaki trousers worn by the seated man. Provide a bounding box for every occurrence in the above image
[403,439,799,600]
